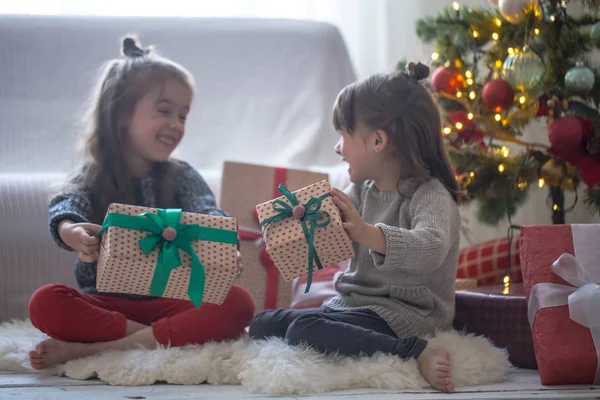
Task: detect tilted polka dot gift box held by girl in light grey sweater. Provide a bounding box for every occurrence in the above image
[256,180,354,293]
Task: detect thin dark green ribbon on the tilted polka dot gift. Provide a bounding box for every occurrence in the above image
[260,184,331,293]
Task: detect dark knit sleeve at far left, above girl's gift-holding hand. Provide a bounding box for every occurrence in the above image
[48,184,92,251]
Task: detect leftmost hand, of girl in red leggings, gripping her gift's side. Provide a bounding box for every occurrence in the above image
[58,221,102,263]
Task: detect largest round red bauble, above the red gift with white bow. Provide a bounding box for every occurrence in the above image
[548,115,585,156]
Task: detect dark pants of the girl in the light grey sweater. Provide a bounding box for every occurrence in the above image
[250,307,427,358]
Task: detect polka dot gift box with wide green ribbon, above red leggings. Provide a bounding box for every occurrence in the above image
[96,204,238,307]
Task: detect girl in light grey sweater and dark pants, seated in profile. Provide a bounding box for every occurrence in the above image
[250,63,460,392]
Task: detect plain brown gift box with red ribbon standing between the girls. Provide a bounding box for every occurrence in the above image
[219,161,328,312]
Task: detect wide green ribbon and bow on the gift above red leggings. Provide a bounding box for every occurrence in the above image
[96,208,238,308]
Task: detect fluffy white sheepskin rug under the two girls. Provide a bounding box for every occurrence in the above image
[0,321,511,396]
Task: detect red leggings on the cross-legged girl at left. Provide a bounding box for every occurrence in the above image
[29,285,254,346]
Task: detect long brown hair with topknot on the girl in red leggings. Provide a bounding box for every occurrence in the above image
[70,36,194,224]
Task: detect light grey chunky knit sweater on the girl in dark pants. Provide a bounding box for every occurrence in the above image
[325,179,460,336]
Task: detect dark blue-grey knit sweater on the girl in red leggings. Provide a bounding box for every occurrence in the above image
[49,160,227,299]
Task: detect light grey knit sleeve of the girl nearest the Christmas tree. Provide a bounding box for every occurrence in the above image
[371,181,460,274]
